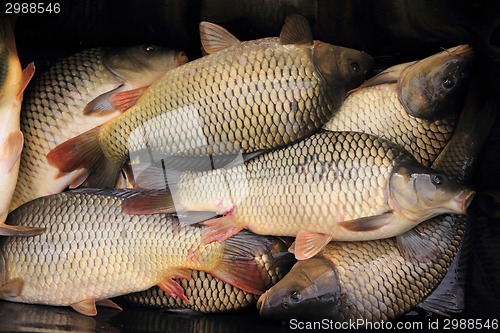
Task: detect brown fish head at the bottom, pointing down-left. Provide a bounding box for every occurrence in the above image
[257,257,340,319]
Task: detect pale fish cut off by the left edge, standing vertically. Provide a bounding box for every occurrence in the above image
[0,16,37,236]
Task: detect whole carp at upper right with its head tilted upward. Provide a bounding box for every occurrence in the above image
[323,45,474,166]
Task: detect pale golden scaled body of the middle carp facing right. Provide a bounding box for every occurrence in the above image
[175,133,396,237]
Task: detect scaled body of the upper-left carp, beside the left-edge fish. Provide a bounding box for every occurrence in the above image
[11,49,116,210]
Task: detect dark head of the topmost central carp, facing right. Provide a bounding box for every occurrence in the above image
[313,41,373,92]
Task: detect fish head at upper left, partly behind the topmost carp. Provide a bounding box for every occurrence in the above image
[103,44,188,86]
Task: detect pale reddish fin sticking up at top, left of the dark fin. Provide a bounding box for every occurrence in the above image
[200,22,241,54]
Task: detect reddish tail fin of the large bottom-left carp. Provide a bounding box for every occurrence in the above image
[208,231,273,295]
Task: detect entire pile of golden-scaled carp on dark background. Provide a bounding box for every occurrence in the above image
[0,15,496,321]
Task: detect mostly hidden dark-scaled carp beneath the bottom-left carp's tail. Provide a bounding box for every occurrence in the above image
[116,238,295,313]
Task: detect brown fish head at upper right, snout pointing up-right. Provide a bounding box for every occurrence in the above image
[398,45,474,120]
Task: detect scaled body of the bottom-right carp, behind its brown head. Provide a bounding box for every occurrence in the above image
[312,215,466,321]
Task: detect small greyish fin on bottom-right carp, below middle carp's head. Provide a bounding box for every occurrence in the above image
[396,229,441,262]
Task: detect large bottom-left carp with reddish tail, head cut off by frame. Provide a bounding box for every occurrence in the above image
[0,189,273,315]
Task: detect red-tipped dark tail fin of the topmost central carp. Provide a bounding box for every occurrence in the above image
[47,126,121,187]
